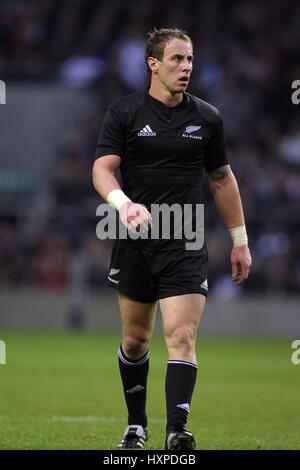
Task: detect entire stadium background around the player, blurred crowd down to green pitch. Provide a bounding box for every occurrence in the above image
[0,0,300,448]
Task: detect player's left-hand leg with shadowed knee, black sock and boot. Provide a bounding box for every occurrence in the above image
[118,293,157,446]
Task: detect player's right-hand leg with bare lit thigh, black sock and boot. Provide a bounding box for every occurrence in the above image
[160,294,206,449]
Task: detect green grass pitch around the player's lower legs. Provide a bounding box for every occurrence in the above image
[0,332,300,450]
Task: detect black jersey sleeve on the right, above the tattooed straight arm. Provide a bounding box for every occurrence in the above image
[204,119,229,172]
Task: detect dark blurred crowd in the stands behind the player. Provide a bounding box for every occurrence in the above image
[0,0,300,297]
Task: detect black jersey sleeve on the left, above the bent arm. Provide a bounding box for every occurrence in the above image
[95,106,125,159]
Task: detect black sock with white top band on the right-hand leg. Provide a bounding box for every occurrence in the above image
[166,359,197,432]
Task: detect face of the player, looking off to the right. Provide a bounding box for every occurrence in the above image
[151,38,193,93]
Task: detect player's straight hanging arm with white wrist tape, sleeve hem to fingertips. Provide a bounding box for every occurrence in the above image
[208,165,252,284]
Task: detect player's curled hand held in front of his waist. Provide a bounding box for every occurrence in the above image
[119,201,152,233]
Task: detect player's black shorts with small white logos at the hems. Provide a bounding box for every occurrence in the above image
[108,242,208,303]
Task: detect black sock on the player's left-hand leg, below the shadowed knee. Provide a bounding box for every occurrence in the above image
[118,346,149,427]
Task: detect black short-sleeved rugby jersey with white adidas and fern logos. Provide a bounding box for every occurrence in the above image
[95,90,228,250]
